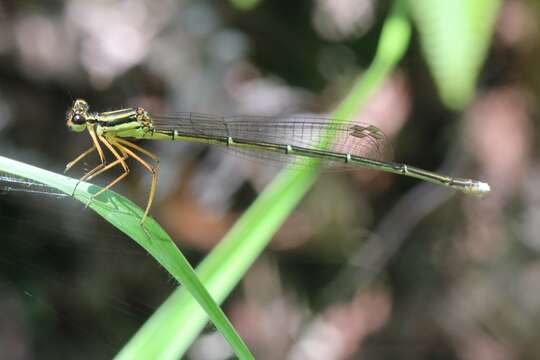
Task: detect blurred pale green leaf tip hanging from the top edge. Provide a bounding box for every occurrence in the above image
[408,0,500,110]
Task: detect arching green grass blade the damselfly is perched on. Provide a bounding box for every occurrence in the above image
[0,156,253,359]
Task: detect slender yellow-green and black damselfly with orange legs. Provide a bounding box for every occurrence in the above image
[66,99,490,223]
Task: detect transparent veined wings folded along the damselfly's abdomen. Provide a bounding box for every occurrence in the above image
[151,113,391,170]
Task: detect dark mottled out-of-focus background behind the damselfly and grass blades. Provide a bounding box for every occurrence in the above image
[0,0,540,359]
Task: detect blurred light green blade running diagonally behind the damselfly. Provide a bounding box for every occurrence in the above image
[118,0,411,359]
